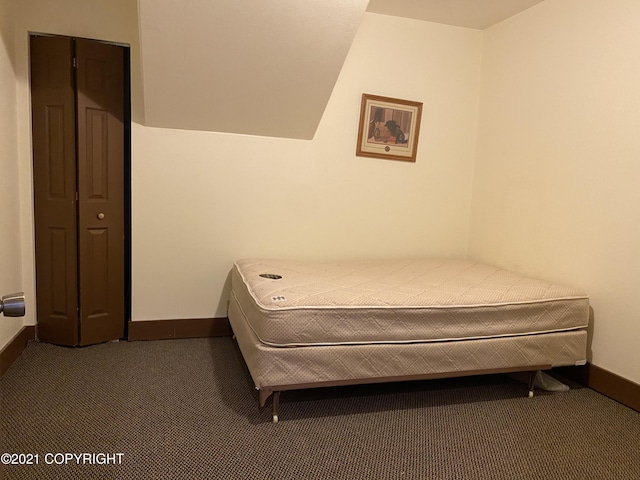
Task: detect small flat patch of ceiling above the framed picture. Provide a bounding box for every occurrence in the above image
[367,0,543,30]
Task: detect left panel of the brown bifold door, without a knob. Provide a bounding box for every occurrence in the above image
[30,37,78,345]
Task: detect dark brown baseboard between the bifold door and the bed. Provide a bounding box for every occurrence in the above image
[128,317,232,341]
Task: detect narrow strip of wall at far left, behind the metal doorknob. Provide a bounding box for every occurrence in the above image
[0,0,23,349]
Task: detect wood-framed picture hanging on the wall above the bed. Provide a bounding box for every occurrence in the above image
[356,93,422,162]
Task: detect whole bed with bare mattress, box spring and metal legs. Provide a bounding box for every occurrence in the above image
[228,259,589,422]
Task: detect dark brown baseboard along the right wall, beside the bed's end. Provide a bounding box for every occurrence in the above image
[557,363,640,412]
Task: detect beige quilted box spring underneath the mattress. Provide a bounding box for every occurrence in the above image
[229,297,587,390]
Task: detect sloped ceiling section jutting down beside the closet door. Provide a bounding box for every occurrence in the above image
[138,0,368,139]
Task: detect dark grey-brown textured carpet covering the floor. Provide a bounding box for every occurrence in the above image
[0,337,640,480]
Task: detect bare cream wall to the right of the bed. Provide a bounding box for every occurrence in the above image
[469,0,640,383]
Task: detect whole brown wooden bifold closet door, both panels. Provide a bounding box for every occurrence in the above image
[30,35,127,346]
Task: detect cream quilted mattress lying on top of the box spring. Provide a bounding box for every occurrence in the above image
[231,259,589,347]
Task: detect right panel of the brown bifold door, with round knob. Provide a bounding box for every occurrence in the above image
[76,39,125,345]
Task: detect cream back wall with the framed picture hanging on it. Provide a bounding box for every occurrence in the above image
[132,14,482,320]
